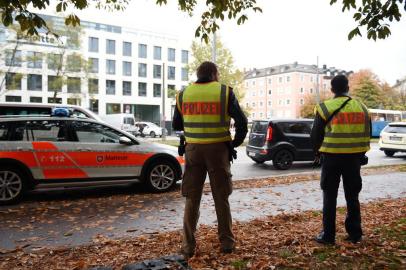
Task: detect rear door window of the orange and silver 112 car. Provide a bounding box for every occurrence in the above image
[24,120,68,142]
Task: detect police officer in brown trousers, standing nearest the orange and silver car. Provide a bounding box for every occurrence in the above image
[172,62,248,258]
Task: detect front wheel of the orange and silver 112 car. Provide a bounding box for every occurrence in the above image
[145,160,176,192]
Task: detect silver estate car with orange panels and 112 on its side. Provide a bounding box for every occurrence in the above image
[0,109,184,204]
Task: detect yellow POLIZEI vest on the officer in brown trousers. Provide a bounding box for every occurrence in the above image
[176,82,231,144]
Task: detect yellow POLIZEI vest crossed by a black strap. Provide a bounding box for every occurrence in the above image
[315,97,371,154]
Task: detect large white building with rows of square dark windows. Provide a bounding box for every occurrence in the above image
[0,15,190,122]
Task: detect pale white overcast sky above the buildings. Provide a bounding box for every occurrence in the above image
[38,0,406,84]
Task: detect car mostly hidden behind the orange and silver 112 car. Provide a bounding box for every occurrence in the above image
[0,102,102,121]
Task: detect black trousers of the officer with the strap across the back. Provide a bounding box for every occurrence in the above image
[320,154,363,240]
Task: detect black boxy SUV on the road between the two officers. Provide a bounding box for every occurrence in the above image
[246,119,314,170]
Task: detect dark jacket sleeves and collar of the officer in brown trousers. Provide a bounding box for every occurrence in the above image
[172,79,248,147]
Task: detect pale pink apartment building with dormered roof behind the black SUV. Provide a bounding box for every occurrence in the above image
[241,62,351,121]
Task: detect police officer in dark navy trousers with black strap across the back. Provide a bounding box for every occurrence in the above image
[311,75,371,244]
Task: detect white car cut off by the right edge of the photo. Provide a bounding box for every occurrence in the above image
[379,122,406,157]
